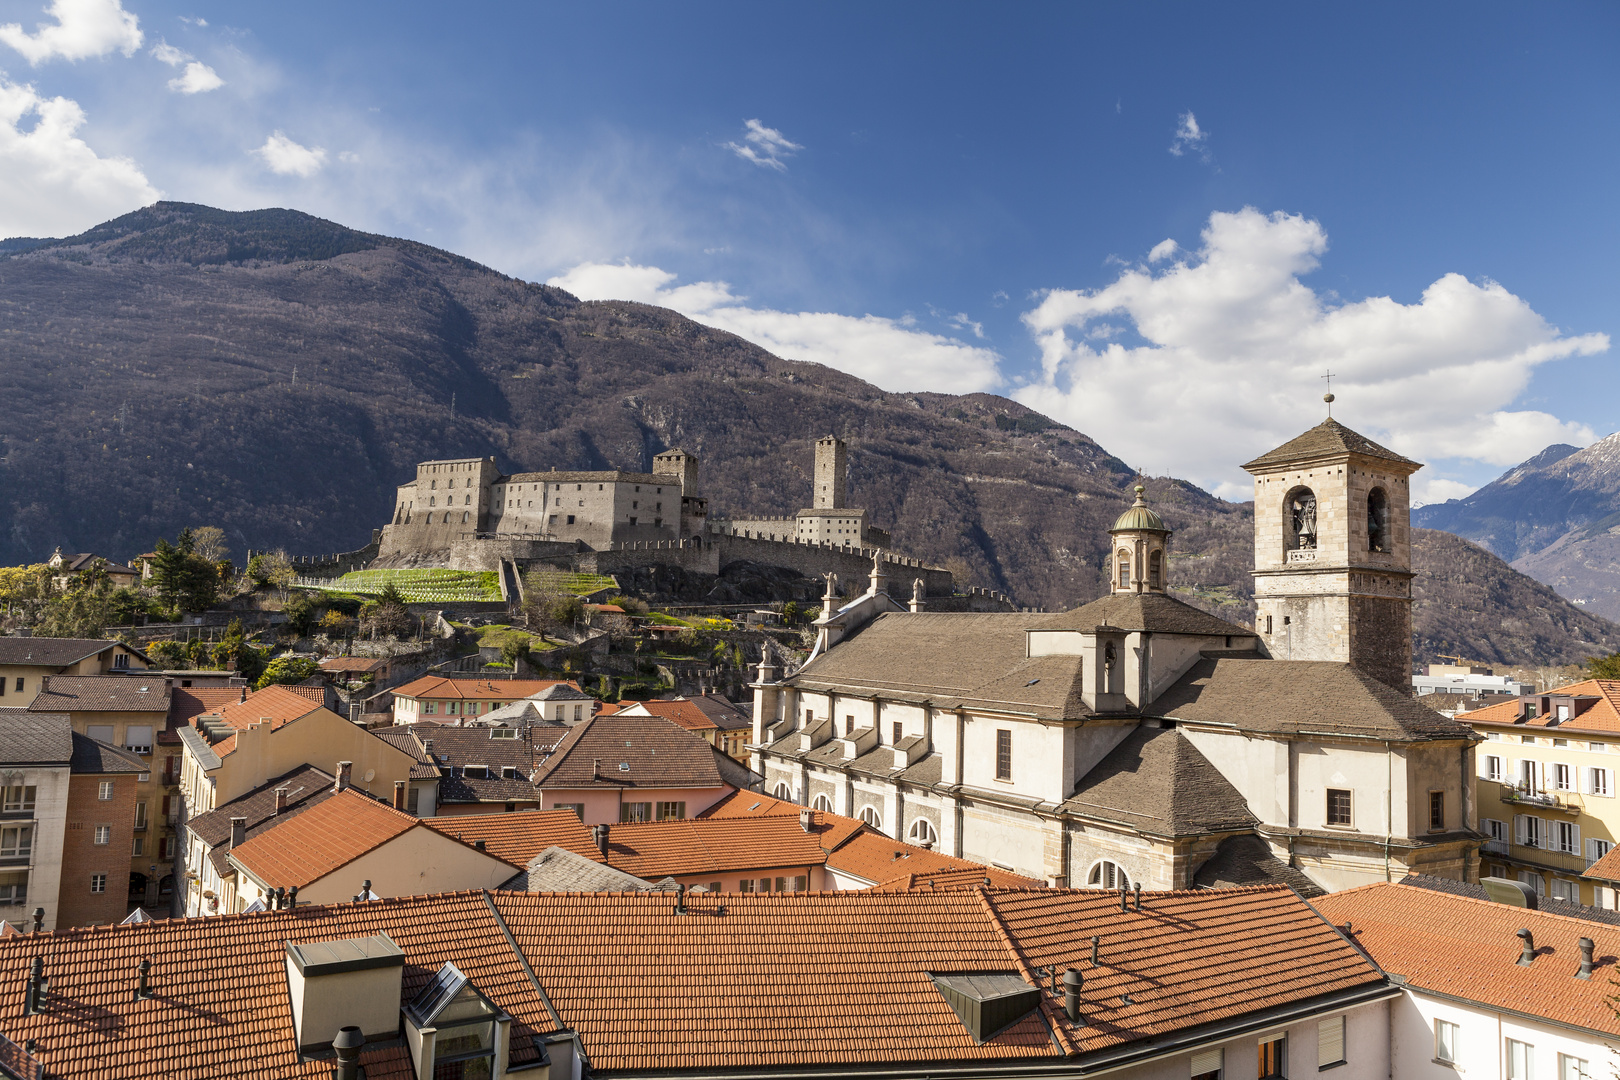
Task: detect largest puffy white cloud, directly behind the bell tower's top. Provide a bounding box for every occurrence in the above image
[1014,207,1609,497]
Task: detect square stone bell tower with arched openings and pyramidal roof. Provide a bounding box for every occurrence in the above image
[1243,419,1422,693]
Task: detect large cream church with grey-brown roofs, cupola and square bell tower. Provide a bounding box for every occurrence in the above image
[752,419,1481,895]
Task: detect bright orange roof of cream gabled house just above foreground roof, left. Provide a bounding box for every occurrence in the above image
[230,789,418,889]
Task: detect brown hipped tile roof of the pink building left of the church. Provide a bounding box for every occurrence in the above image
[538,712,745,790]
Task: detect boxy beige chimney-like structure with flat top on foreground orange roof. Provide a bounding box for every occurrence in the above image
[287,934,405,1051]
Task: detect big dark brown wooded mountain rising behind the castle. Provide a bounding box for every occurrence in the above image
[0,202,1597,662]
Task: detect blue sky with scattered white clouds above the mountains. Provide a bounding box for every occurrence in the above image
[0,0,1620,502]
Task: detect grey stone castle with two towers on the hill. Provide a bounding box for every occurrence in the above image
[374,436,1013,610]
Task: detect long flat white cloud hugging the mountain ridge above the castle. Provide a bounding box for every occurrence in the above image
[546,262,1001,393]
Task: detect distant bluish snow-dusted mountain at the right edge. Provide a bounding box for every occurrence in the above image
[1413,432,1620,619]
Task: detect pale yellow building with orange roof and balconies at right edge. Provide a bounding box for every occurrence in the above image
[1456,678,1620,910]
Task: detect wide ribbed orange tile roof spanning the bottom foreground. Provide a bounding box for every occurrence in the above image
[0,887,1393,1080]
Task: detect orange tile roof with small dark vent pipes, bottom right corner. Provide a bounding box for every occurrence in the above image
[1314,882,1620,1036]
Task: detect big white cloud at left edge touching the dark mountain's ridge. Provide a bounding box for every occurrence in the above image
[0,76,160,236]
